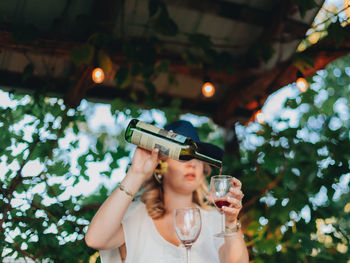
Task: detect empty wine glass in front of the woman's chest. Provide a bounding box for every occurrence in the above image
[174,207,202,263]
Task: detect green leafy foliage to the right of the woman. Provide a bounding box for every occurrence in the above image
[225,57,350,262]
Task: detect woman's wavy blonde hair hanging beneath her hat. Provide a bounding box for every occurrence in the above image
[141,161,211,219]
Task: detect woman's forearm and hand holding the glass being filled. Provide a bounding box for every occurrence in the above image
[219,178,249,263]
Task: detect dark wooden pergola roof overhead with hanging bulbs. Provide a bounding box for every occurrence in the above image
[0,0,348,126]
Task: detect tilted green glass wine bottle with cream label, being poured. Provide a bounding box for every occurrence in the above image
[125,119,222,168]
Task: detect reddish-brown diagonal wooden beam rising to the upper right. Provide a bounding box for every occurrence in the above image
[215,30,350,124]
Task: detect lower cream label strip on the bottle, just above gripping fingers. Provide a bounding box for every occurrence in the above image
[131,130,181,160]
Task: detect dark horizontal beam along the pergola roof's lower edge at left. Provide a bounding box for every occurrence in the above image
[0,71,217,117]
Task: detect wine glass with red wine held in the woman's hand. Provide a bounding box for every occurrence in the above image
[210,175,233,237]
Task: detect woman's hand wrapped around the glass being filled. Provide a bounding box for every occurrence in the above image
[222,178,244,227]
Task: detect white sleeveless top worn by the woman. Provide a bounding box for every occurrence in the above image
[100,202,224,263]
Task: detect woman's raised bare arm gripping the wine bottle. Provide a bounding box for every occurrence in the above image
[85,148,158,250]
